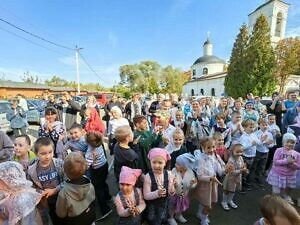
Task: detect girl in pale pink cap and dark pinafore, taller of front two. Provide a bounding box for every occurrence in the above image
[143,148,175,225]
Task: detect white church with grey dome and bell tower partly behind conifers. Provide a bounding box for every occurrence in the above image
[183,0,290,97]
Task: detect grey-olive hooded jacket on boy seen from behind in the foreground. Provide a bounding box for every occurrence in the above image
[56,177,95,218]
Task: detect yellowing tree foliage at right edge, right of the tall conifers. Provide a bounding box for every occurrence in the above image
[275,38,300,93]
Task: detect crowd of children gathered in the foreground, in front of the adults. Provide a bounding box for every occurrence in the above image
[0,93,300,225]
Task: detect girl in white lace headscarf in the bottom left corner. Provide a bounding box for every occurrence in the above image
[0,161,43,225]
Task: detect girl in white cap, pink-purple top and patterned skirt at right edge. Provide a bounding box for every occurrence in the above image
[267,133,300,204]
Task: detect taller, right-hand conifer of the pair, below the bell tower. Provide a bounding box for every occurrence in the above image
[244,15,276,96]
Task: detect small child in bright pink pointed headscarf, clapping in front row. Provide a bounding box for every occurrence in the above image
[115,166,146,225]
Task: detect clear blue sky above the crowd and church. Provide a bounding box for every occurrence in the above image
[0,0,300,87]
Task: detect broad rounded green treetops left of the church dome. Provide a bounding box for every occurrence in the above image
[119,61,188,94]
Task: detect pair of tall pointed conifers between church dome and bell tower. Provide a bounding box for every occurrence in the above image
[225,15,276,98]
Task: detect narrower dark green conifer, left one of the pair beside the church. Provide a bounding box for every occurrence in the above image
[224,24,249,98]
